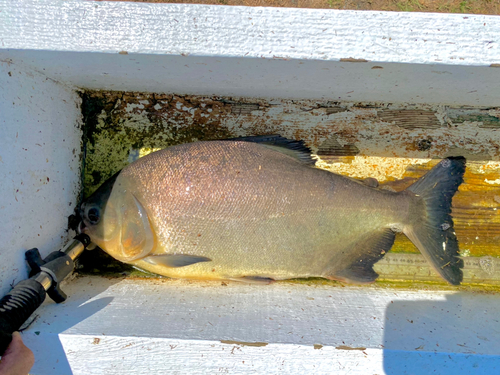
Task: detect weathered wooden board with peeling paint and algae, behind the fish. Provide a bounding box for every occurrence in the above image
[83,92,500,272]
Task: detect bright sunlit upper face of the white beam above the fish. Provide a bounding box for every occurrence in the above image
[0,0,500,66]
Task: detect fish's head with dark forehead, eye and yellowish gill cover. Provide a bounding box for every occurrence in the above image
[80,173,156,262]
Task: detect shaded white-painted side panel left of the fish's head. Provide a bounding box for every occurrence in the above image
[0,62,81,296]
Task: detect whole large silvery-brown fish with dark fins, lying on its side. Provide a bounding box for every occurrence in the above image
[80,135,466,285]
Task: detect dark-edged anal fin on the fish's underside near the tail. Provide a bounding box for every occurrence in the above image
[326,229,396,284]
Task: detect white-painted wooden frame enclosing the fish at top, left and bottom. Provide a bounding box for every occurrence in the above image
[0,0,500,374]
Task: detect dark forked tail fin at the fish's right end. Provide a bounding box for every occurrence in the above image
[404,157,465,285]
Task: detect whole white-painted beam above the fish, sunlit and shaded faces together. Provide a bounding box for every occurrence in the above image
[0,0,500,106]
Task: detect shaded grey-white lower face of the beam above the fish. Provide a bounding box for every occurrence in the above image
[6,50,500,107]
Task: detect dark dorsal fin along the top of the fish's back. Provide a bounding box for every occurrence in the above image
[224,134,316,165]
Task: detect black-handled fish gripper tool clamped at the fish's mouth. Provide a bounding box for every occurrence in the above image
[0,233,90,356]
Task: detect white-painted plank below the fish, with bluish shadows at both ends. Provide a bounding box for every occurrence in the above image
[24,277,500,375]
